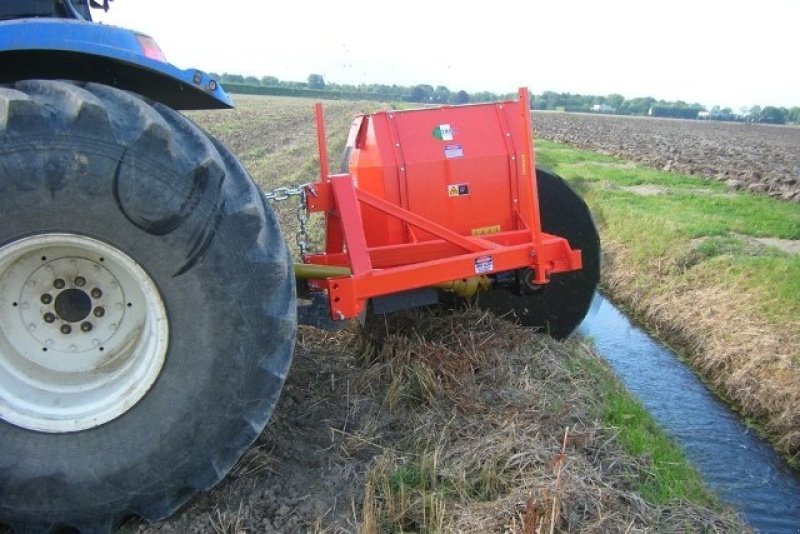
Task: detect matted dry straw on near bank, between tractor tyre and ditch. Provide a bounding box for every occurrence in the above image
[346,310,744,533]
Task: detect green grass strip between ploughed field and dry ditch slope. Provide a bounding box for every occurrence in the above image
[536,141,800,336]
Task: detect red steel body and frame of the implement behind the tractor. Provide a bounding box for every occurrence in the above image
[306,89,581,318]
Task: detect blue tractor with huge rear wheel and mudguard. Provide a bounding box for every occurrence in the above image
[0,0,296,532]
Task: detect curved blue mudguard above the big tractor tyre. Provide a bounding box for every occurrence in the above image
[0,18,233,110]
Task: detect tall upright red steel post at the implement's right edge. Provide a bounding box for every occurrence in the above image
[519,87,547,284]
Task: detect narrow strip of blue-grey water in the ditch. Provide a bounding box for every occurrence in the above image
[579,295,800,533]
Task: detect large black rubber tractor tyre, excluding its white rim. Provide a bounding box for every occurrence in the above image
[0,81,296,532]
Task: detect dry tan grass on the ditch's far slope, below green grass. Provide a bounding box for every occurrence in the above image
[603,240,800,462]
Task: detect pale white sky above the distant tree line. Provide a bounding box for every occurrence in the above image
[95,0,800,110]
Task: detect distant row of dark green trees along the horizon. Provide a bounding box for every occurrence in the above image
[211,73,800,124]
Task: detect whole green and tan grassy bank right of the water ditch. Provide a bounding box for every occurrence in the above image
[537,141,800,463]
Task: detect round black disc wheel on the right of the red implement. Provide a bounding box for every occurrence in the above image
[477,168,600,339]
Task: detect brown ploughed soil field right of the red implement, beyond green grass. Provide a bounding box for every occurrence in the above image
[533,112,800,202]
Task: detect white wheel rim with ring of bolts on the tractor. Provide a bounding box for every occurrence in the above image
[0,234,169,432]
